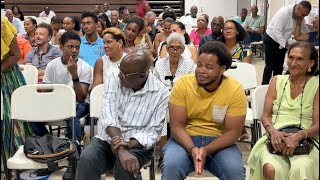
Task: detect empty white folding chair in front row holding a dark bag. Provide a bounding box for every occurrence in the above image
[7,84,76,178]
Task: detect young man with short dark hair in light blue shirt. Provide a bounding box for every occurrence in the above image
[79,12,105,67]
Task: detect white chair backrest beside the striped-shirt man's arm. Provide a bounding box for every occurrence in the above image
[90,84,104,118]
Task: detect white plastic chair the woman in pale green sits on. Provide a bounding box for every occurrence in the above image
[251,85,269,143]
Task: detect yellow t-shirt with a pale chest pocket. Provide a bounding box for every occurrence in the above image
[170,73,247,136]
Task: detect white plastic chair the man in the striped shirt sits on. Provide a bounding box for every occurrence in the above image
[90,84,155,180]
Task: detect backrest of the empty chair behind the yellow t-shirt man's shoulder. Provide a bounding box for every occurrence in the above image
[224,62,258,90]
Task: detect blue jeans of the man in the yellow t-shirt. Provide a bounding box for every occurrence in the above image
[160,136,246,180]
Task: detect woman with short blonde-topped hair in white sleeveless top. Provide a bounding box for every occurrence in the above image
[92,27,126,88]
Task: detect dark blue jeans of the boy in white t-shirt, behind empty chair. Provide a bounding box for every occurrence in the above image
[29,102,89,142]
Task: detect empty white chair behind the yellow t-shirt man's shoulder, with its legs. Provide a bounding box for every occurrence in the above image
[224,62,258,146]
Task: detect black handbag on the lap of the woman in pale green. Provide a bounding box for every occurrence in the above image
[266,126,315,155]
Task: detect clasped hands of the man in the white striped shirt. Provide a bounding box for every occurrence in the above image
[111,136,140,176]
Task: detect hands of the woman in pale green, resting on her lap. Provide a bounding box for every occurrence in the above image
[270,129,299,156]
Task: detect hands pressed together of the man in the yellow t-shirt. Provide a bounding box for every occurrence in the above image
[190,147,208,177]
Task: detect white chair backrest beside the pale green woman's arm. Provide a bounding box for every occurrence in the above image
[251,85,269,119]
